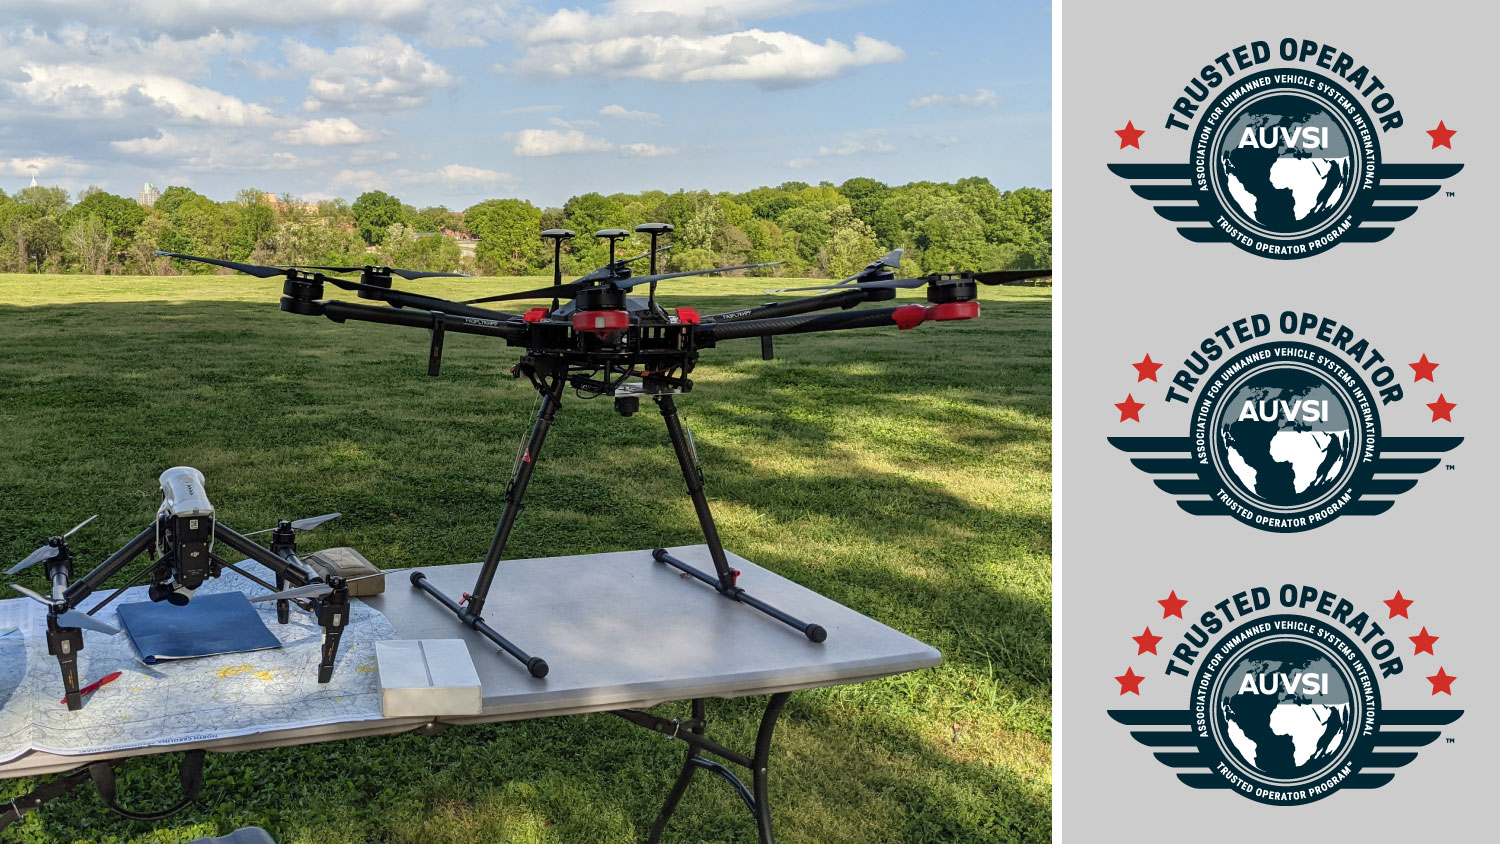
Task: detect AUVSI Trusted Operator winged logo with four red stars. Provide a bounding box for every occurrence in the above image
[1110,310,1463,532]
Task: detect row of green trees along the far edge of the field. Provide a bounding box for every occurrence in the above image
[0,178,1052,277]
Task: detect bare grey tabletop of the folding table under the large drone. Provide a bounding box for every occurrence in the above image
[0,546,942,778]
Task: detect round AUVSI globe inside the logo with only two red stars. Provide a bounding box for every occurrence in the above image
[1215,94,1358,235]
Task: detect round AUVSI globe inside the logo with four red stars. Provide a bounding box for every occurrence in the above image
[1217,367,1358,508]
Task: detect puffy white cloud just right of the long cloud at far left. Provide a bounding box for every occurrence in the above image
[287,34,458,111]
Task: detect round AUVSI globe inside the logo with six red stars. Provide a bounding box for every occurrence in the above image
[1214,640,1361,783]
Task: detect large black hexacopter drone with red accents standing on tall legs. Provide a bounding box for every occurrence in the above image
[158,223,1052,678]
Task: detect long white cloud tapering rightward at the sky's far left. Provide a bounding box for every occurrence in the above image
[9,64,281,126]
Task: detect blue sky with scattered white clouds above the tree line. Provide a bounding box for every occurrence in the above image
[0,0,1052,208]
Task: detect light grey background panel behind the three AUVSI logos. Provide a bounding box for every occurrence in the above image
[1053,0,1500,844]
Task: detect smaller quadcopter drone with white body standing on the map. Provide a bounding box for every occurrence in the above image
[6,466,360,709]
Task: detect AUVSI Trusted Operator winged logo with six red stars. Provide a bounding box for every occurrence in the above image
[1109,583,1463,805]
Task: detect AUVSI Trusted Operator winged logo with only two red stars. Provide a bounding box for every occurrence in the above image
[1109,37,1464,258]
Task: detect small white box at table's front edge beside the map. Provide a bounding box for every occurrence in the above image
[375,639,485,718]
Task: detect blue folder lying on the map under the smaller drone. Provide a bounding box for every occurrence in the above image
[119,592,281,666]
